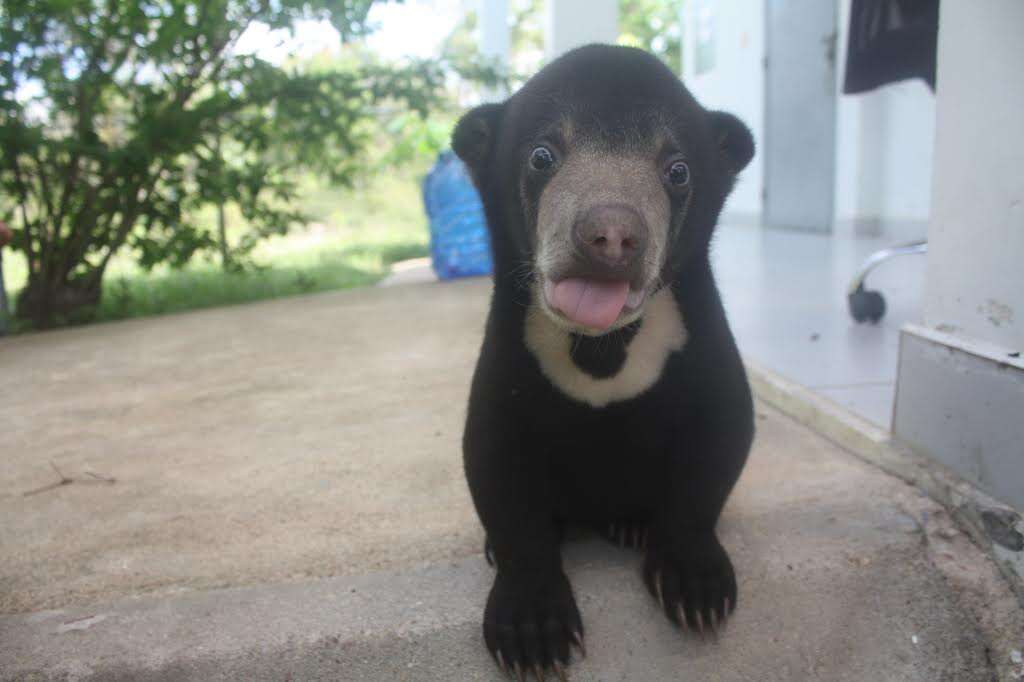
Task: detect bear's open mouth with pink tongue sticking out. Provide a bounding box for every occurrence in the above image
[543,278,646,332]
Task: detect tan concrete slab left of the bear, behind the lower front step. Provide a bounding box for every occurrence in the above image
[0,280,489,612]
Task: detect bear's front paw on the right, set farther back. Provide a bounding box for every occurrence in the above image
[643,532,736,637]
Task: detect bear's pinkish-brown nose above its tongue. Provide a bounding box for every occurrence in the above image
[572,204,647,279]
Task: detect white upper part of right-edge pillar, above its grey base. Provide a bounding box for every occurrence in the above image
[925,0,1024,351]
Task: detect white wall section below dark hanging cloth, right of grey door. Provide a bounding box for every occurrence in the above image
[836,0,935,231]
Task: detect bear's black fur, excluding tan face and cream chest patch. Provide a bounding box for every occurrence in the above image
[453,46,754,670]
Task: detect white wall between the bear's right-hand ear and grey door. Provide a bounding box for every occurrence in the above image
[682,0,765,218]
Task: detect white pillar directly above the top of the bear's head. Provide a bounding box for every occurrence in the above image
[544,0,618,61]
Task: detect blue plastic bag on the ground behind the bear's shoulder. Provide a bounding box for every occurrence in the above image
[423,152,494,280]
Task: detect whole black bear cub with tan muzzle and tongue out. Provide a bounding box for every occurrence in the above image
[453,45,754,679]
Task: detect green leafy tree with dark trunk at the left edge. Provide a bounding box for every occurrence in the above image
[0,0,444,327]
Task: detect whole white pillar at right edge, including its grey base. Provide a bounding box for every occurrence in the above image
[893,0,1024,509]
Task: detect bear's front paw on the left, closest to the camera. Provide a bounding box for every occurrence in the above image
[483,567,585,680]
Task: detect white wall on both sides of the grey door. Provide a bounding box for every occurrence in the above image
[682,0,935,229]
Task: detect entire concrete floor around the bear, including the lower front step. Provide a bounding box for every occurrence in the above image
[0,280,1024,682]
